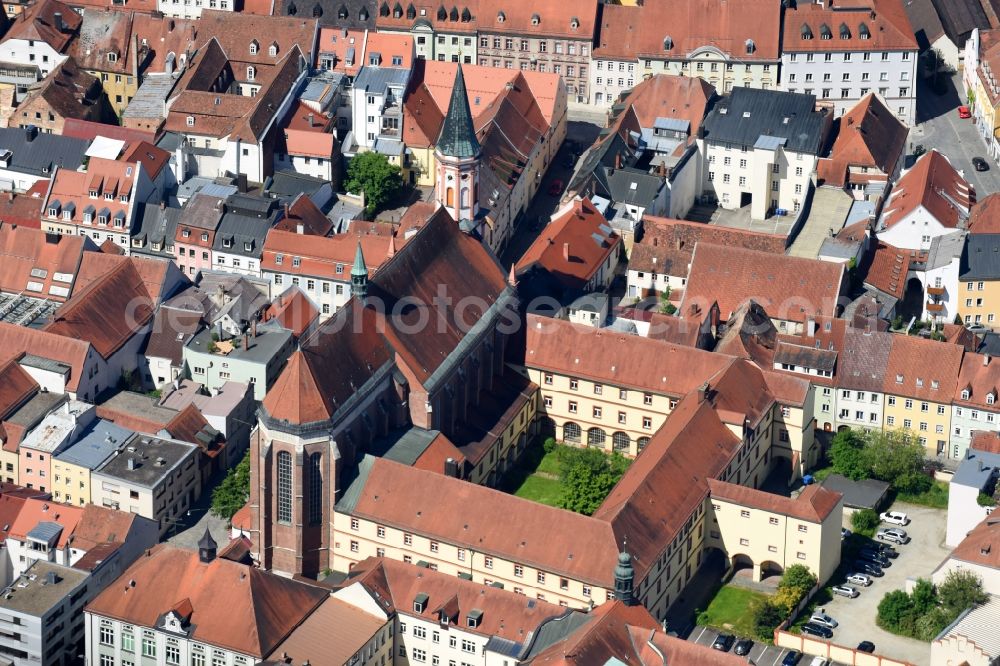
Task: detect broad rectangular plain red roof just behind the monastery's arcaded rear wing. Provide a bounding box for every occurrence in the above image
[681,243,844,322]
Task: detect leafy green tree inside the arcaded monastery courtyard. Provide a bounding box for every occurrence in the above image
[559,448,629,516]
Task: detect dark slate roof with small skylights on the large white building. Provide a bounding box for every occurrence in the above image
[702,88,826,155]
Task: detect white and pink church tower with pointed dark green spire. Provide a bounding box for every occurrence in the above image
[434,64,482,222]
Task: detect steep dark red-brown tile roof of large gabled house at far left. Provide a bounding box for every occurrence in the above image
[45,255,153,359]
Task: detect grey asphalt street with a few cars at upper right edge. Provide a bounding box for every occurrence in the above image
[907,74,1000,199]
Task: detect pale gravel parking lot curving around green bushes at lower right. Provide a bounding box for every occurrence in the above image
[804,503,949,665]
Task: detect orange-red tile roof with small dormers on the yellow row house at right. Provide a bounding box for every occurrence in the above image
[882,335,965,396]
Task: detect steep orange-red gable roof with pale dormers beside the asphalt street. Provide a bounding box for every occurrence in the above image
[879,150,975,229]
